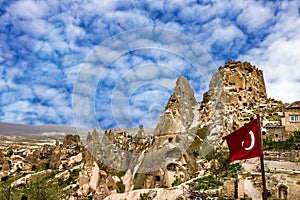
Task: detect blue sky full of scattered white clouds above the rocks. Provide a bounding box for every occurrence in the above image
[0,0,300,129]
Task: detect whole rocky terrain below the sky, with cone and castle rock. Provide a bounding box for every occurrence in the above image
[0,61,300,199]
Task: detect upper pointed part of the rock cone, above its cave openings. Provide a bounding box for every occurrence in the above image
[154,76,197,135]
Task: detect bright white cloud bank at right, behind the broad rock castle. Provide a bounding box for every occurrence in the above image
[239,2,300,102]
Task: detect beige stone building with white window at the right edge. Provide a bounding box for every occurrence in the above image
[285,101,300,134]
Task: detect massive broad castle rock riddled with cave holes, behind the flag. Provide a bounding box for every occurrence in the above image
[199,61,267,142]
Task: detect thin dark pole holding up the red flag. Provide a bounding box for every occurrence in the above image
[256,114,267,200]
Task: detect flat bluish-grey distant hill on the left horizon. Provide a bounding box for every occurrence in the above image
[0,122,90,137]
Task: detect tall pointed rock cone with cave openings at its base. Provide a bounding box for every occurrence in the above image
[122,76,197,191]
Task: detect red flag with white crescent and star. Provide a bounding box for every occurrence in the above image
[223,119,260,163]
